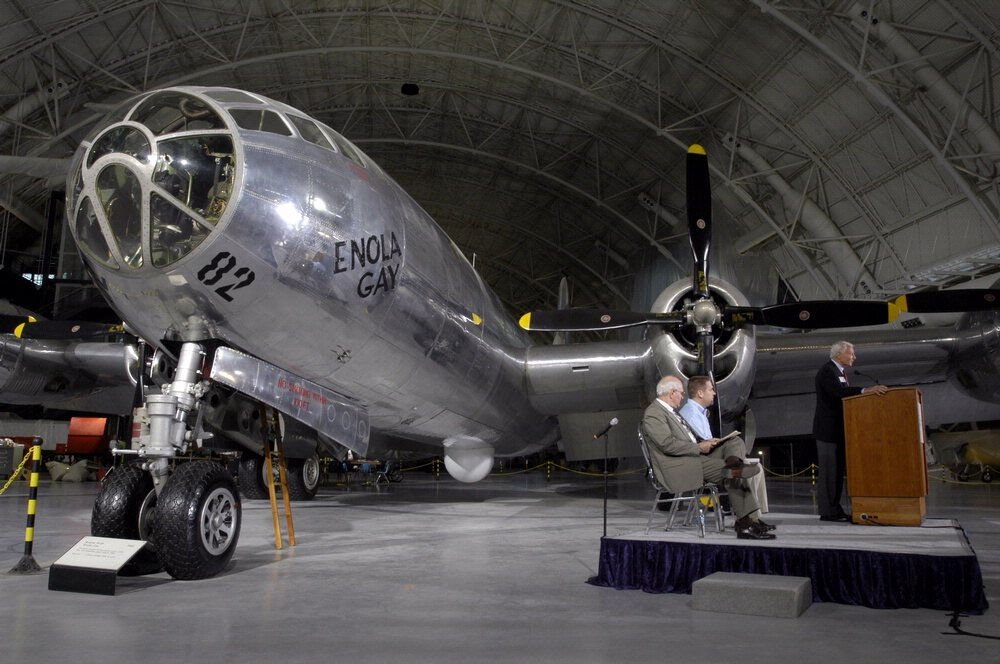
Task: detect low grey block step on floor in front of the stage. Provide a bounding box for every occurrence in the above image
[691,572,812,618]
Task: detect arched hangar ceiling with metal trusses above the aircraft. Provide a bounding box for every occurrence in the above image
[0,0,1000,320]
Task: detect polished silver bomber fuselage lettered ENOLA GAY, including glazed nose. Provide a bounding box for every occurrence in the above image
[67,88,556,462]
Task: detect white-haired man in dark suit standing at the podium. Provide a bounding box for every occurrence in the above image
[813,341,887,521]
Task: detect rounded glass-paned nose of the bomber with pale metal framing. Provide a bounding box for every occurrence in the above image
[67,90,237,270]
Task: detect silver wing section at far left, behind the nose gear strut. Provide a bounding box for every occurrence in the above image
[0,334,139,415]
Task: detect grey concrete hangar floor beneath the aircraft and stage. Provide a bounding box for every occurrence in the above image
[0,462,1000,664]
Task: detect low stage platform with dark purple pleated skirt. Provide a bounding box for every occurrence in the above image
[589,512,988,614]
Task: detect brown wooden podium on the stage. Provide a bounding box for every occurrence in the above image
[844,387,927,526]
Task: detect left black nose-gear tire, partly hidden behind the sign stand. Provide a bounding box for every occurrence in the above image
[90,464,163,576]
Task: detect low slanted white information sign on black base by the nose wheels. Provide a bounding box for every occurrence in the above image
[49,537,146,595]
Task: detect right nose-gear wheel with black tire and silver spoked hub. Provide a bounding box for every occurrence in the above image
[153,460,242,580]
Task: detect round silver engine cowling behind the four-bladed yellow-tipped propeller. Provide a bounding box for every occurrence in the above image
[649,279,757,419]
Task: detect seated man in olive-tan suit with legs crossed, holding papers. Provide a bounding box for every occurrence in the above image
[642,376,774,539]
